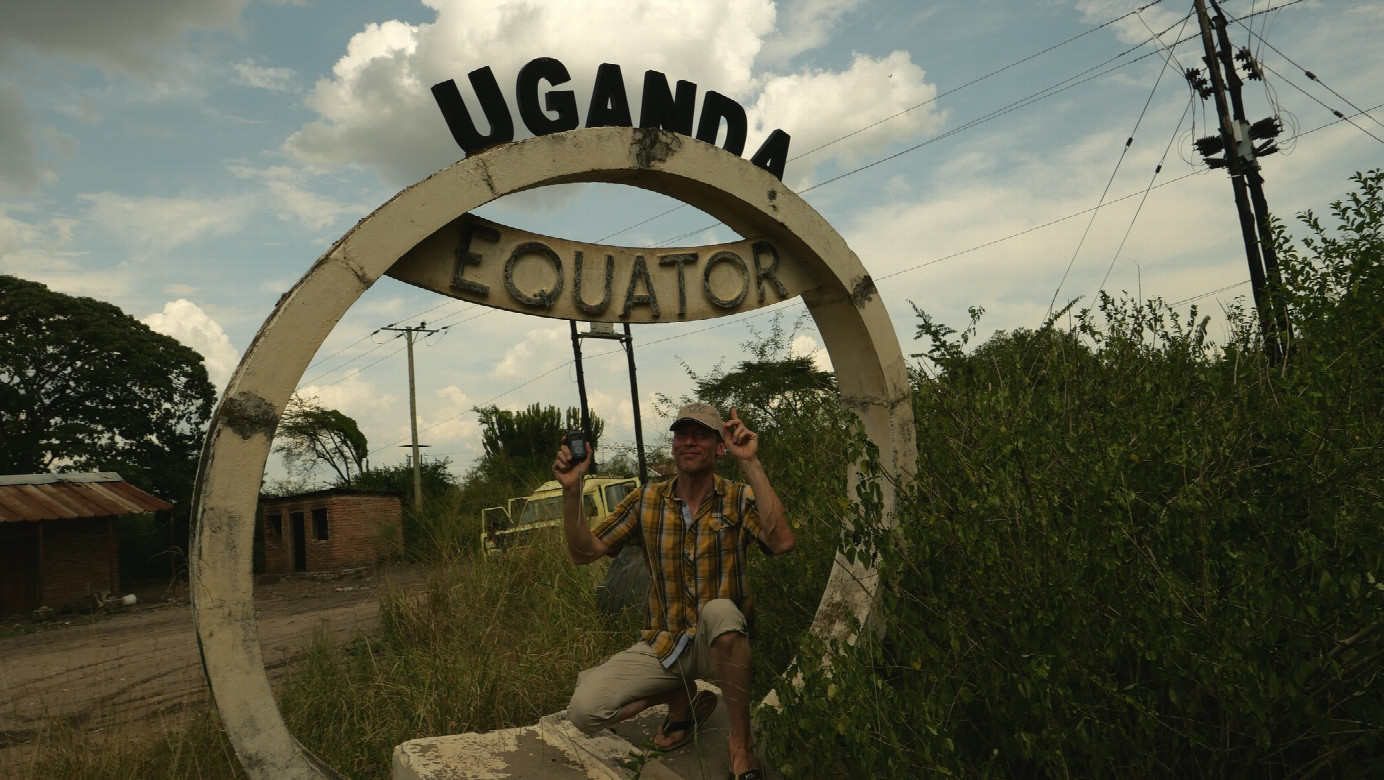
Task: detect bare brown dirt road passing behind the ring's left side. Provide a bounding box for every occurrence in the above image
[0,564,424,748]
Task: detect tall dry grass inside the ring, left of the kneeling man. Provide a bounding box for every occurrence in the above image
[280,544,637,777]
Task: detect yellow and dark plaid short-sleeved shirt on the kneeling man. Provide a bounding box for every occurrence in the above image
[591,477,760,661]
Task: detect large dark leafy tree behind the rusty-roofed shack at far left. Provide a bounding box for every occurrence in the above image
[0,275,216,486]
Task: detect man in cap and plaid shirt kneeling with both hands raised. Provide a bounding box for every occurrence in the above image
[552,404,796,780]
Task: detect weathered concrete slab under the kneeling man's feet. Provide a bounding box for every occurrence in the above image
[393,686,782,780]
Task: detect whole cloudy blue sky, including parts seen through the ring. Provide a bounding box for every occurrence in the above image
[0,0,1384,486]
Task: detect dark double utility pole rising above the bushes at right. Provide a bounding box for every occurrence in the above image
[1187,0,1291,362]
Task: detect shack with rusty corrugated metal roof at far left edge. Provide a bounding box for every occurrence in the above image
[0,472,173,617]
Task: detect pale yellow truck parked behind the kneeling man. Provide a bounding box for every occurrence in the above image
[480,474,639,555]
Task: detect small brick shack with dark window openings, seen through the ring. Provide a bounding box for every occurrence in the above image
[263,488,404,574]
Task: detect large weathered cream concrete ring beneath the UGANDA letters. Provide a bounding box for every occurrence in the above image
[190,127,916,779]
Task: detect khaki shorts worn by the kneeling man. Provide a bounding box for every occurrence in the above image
[567,599,749,736]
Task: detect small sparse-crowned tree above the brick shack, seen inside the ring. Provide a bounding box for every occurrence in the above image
[274,396,370,485]
